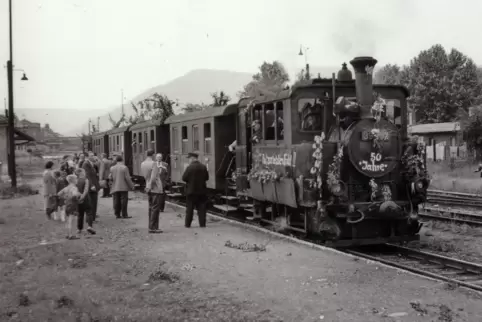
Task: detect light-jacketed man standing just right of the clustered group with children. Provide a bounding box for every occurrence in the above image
[110,155,134,218]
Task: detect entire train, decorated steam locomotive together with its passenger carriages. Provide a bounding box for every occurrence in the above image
[86,57,429,247]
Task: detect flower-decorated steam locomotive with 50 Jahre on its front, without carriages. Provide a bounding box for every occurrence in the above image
[234,57,429,247]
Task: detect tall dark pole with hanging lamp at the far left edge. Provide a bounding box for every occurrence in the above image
[7,0,28,190]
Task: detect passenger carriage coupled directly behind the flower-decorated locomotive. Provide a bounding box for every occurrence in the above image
[166,104,238,191]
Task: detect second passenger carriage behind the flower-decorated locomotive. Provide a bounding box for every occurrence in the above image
[130,120,170,186]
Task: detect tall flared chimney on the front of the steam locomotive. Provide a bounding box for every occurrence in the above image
[350,57,377,119]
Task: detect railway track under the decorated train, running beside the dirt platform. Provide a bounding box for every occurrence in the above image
[165,198,482,292]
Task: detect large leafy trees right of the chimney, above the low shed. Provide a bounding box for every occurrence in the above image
[376,45,482,123]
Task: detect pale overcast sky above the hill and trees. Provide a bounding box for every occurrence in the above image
[0,0,482,108]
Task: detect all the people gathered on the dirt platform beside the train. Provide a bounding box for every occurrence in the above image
[43,150,209,239]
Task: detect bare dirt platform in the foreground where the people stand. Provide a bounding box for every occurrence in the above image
[0,190,482,322]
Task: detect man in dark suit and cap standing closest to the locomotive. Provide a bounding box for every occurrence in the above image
[182,153,209,228]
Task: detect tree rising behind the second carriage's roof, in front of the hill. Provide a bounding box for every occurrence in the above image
[128,93,178,125]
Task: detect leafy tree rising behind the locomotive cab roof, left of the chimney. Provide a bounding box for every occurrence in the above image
[238,61,290,97]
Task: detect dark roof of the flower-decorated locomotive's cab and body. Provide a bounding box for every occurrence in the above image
[238,82,410,107]
